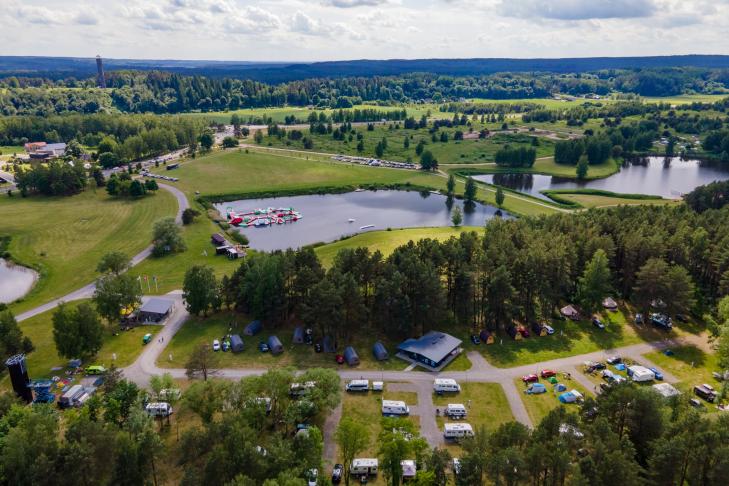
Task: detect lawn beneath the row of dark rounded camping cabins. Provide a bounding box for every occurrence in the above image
[158,311,410,370]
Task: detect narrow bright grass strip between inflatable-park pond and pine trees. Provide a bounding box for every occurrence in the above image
[314,226,483,267]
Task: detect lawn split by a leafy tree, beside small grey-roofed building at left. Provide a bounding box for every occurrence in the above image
[5,301,161,380]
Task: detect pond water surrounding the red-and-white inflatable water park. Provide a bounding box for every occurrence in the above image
[215,191,509,251]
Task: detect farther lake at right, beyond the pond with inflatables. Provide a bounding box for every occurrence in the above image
[474,157,729,199]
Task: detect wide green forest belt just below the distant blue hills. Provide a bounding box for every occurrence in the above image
[0,68,729,116]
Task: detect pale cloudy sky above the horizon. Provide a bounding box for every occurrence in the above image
[0,0,729,61]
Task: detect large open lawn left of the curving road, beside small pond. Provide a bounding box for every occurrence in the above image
[0,188,177,313]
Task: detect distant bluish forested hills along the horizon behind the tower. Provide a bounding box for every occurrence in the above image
[0,55,729,83]
